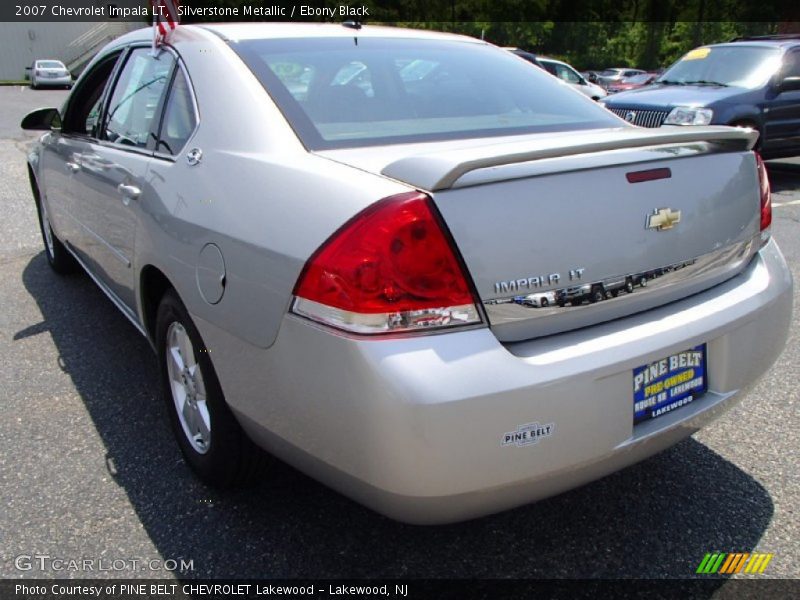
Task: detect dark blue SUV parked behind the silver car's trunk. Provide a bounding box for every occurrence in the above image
[605,34,800,158]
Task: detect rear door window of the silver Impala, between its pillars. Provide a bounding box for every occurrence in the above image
[104,48,175,148]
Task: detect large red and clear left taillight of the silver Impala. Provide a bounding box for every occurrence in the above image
[293,192,480,333]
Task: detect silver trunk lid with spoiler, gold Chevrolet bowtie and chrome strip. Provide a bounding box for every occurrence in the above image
[314,127,760,342]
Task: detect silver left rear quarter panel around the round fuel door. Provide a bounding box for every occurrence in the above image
[136,28,408,347]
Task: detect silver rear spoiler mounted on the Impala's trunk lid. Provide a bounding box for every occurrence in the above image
[381,126,758,192]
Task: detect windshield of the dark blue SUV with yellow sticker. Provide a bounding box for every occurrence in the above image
[659,45,781,89]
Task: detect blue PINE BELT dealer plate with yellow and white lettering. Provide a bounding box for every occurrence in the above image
[633,344,708,424]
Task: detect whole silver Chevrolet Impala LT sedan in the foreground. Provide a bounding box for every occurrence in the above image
[23,24,792,523]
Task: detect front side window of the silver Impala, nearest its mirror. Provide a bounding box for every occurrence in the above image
[61,52,120,138]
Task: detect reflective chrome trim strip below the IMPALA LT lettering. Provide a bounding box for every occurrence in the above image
[483,236,761,333]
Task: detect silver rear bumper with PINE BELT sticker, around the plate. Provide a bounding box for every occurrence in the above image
[198,241,792,523]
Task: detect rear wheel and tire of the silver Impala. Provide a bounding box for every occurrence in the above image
[155,290,269,488]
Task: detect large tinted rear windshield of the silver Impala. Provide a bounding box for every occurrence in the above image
[231,38,619,150]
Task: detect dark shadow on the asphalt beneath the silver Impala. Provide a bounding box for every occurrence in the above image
[17,253,773,585]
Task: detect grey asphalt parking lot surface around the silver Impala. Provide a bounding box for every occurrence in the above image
[0,87,800,578]
